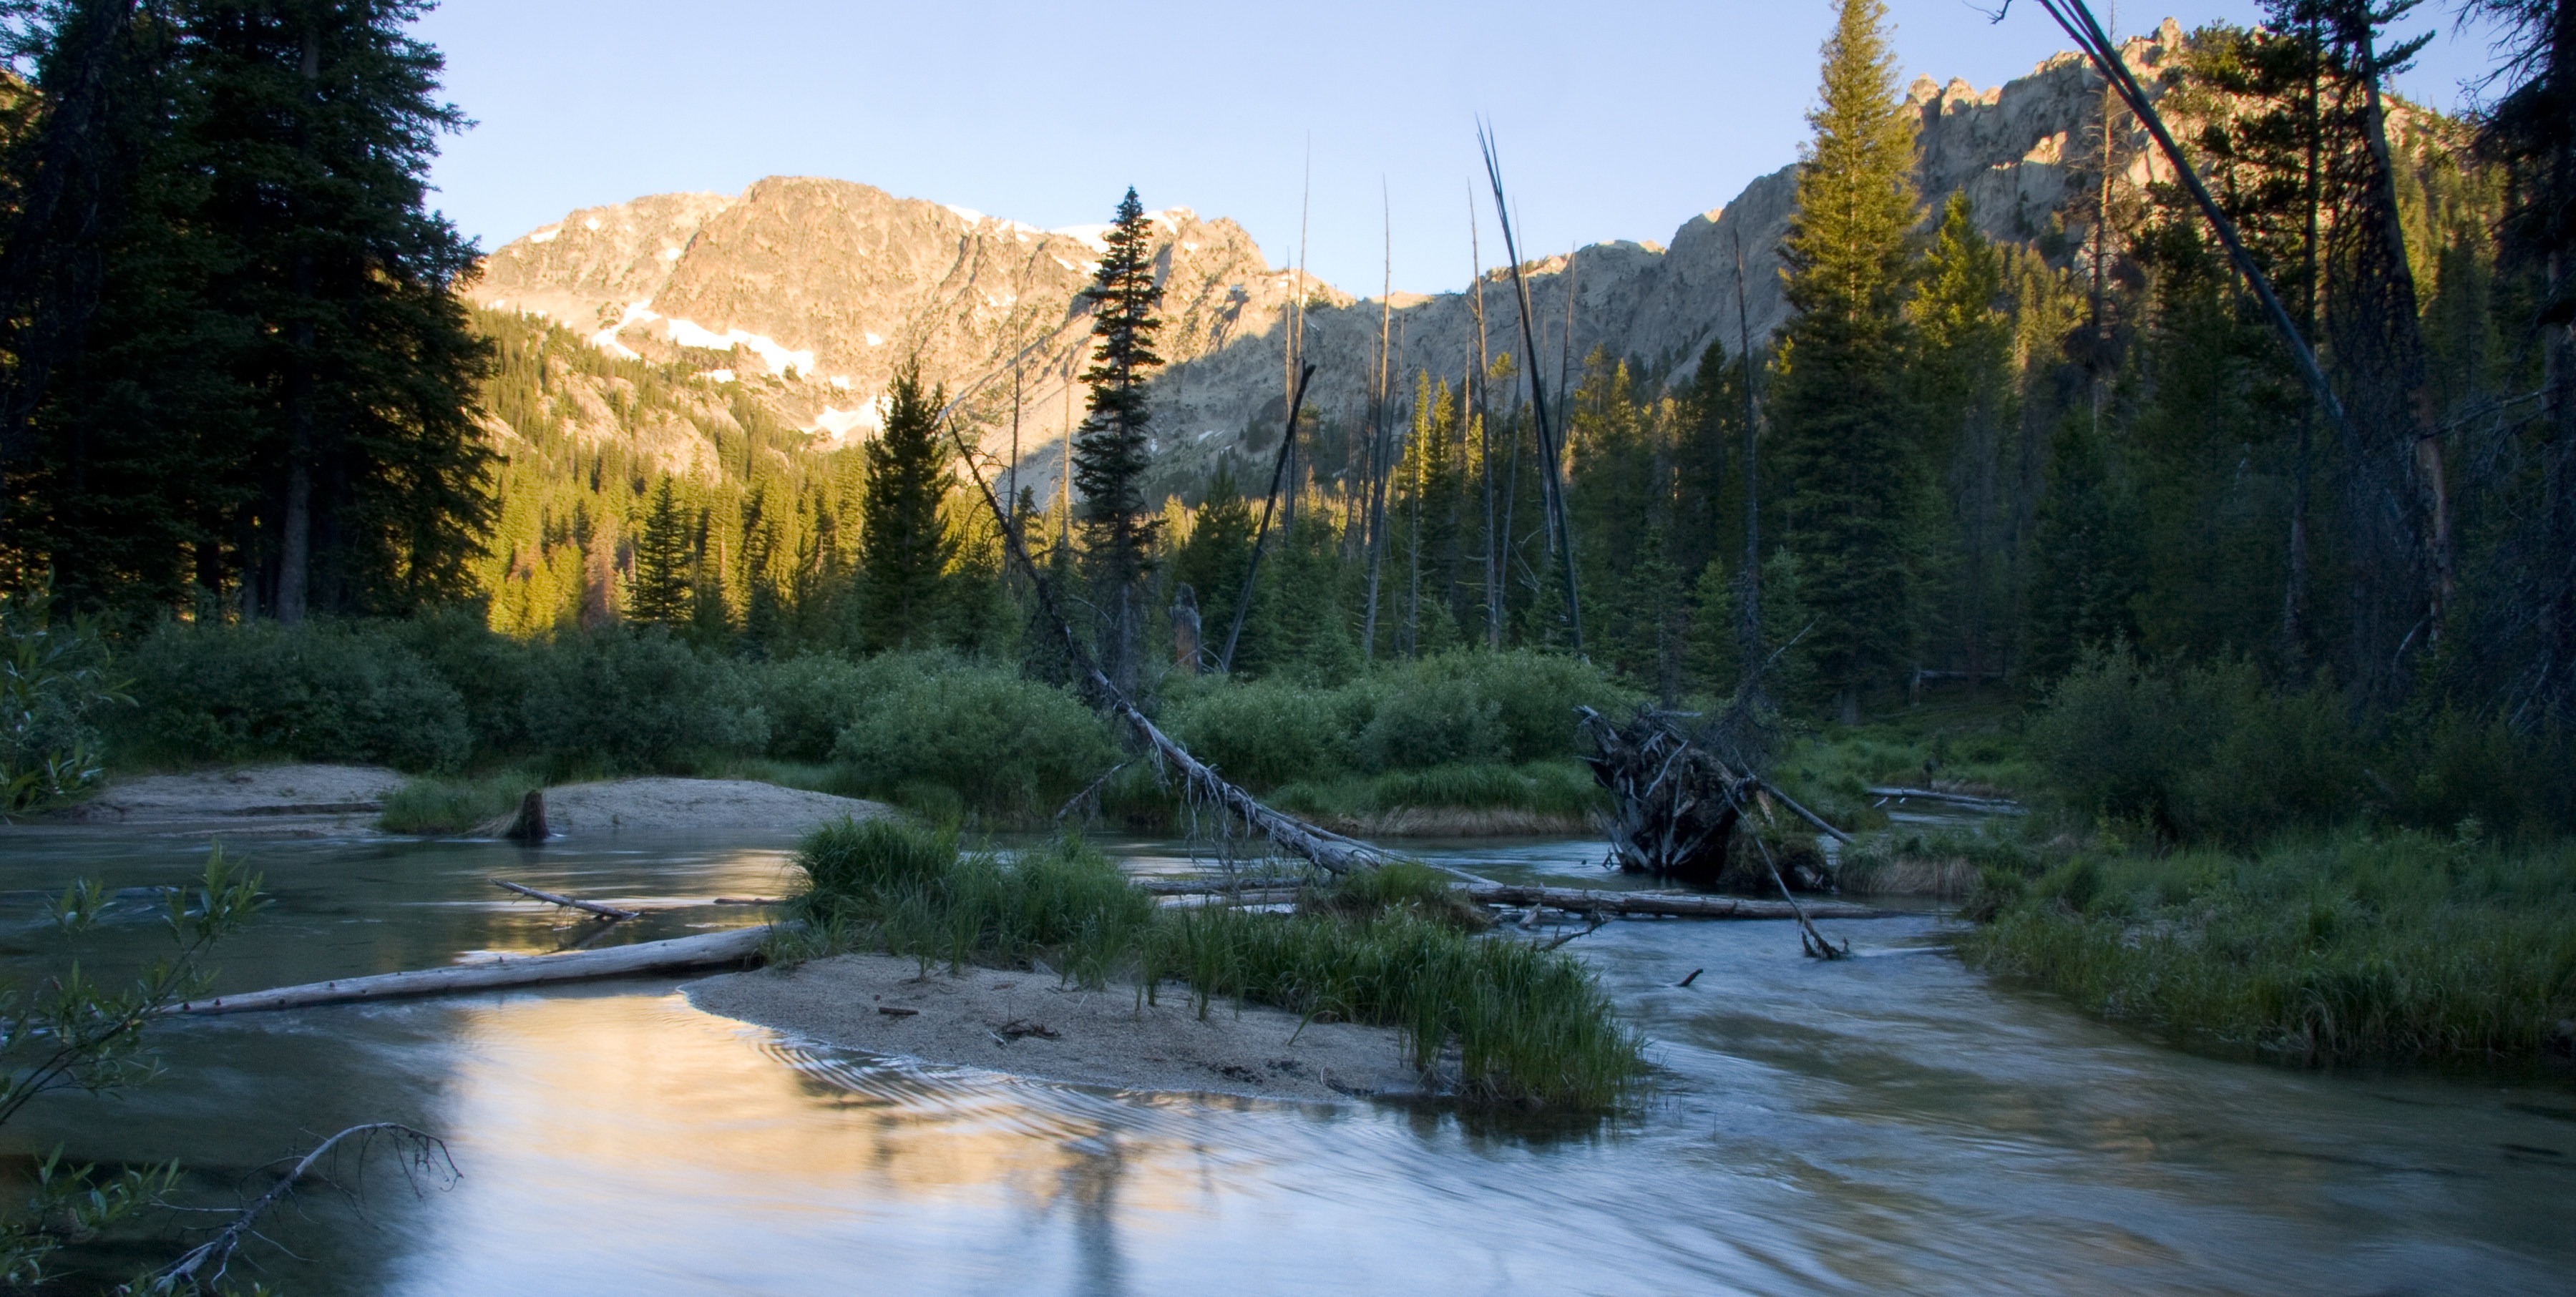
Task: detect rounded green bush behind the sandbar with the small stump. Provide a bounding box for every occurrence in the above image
[523,628,770,775]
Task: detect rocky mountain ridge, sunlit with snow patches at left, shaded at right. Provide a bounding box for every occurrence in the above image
[469,18,2182,504]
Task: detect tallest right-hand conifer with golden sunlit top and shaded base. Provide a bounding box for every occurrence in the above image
[1777,0,1919,720]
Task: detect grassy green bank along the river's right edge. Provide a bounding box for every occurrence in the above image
[1963,826,2576,1063]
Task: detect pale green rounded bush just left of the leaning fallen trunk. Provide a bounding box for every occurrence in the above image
[832,654,1118,816]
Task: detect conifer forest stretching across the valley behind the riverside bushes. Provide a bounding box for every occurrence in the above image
[0,0,2576,828]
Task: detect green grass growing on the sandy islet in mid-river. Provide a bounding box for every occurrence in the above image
[773,818,1644,1107]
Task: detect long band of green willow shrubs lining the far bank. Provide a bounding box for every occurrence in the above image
[108,612,1628,823]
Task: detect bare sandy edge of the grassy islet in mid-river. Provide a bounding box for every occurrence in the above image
[688,955,1422,1102]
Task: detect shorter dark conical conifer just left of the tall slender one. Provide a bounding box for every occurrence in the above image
[858,358,956,649]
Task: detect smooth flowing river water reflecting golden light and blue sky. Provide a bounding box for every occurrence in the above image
[0,831,2576,1294]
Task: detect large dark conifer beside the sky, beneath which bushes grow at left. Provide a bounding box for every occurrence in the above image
[188,0,492,620]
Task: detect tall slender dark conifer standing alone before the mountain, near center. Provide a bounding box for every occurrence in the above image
[1074,188,1162,690]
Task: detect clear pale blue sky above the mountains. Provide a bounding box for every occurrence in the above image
[417,0,2489,296]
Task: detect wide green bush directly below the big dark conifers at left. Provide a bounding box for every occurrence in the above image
[108,620,474,770]
